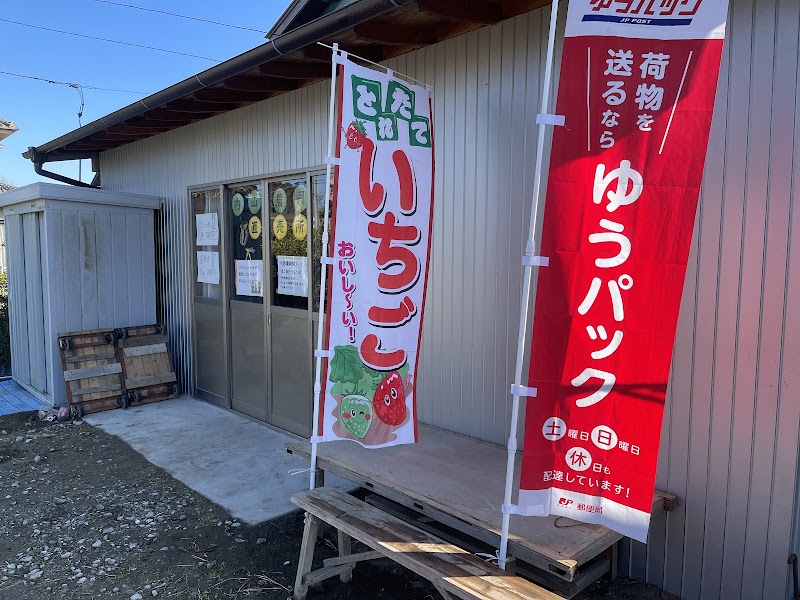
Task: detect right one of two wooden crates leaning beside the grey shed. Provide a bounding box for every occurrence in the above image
[113,325,178,406]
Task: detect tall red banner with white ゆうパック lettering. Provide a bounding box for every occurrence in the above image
[519,0,728,542]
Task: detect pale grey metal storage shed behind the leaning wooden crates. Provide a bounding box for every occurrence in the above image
[0,183,161,406]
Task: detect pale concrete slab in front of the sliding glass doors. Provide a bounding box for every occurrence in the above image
[84,396,354,525]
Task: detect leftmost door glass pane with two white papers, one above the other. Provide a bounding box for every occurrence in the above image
[190,188,222,300]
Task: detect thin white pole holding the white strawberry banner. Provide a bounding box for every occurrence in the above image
[309,44,339,490]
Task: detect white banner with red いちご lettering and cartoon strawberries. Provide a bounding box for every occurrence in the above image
[313,54,433,447]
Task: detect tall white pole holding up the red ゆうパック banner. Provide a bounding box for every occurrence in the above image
[498,0,559,569]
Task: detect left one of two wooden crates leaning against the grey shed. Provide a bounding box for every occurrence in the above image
[58,329,125,418]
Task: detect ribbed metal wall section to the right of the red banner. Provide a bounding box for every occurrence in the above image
[648,0,800,600]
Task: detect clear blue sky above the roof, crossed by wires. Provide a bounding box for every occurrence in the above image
[0,0,290,186]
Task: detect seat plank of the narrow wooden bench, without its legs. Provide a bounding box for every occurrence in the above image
[291,488,561,600]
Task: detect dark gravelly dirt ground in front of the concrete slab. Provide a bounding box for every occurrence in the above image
[0,413,674,600]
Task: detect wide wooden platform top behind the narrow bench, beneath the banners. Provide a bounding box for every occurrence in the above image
[285,425,674,581]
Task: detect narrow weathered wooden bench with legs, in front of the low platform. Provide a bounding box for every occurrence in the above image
[291,488,563,600]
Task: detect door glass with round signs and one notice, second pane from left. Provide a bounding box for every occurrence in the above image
[228,185,264,304]
